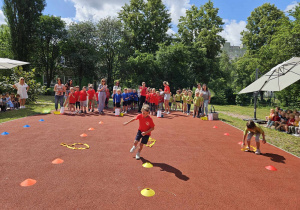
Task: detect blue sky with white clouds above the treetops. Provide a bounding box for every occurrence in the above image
[0,0,299,46]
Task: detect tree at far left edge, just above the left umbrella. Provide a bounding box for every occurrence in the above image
[0,24,13,58]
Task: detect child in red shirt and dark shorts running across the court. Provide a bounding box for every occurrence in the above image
[124,104,155,160]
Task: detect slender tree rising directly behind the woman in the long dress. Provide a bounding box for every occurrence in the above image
[97,17,123,86]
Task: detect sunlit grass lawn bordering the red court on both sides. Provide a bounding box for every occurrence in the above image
[0,96,300,157]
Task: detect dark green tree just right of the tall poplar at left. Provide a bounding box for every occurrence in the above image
[36,15,67,88]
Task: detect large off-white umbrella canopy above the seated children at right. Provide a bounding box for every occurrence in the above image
[239,57,300,94]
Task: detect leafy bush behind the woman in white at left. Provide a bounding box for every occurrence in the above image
[0,68,45,102]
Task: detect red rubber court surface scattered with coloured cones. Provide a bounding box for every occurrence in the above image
[0,112,300,209]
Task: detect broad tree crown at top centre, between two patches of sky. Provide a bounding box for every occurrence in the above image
[119,0,171,53]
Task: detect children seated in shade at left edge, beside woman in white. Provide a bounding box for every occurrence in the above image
[0,93,21,112]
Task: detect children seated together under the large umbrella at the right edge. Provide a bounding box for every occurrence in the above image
[266,107,300,136]
